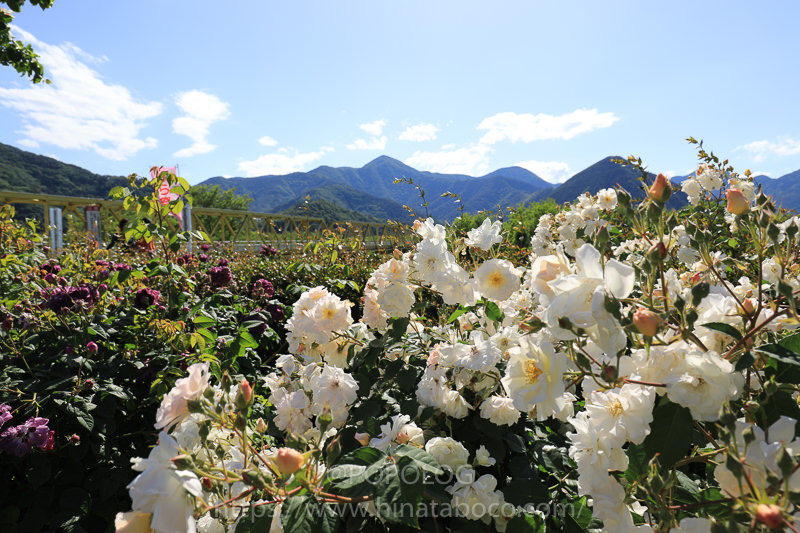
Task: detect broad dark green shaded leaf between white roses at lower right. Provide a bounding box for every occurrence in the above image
[643,398,694,467]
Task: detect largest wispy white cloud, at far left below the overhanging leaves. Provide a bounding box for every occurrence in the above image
[0,26,163,161]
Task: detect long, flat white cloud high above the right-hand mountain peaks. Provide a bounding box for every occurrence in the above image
[478,109,619,144]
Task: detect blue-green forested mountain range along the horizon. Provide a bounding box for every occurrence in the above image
[0,143,800,222]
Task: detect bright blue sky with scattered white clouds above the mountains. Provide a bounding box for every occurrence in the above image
[0,0,800,183]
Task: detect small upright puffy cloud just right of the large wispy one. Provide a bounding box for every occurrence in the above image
[172,90,231,157]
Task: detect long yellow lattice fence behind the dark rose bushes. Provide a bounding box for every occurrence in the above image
[0,191,408,249]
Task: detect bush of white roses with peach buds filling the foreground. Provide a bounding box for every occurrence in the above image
[114,144,800,532]
